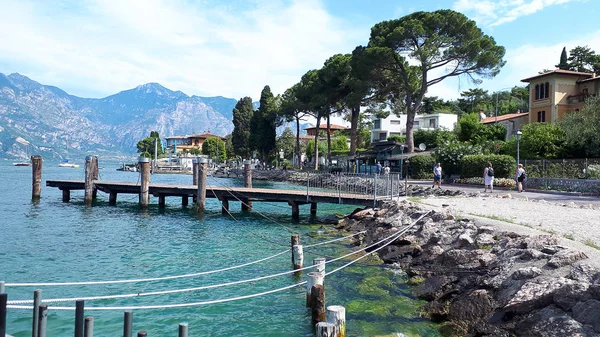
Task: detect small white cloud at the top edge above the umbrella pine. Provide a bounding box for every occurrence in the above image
[452,0,581,26]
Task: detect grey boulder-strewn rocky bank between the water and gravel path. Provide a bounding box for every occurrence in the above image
[336,200,600,337]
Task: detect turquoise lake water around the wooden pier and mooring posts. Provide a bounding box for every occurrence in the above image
[0,160,438,337]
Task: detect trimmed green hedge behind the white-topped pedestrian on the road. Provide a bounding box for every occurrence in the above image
[460,154,516,178]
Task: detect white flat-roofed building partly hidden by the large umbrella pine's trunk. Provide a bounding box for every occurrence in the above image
[371,113,458,143]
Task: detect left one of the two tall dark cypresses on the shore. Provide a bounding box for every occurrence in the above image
[231,97,254,158]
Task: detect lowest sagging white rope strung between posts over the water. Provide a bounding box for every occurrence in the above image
[7,211,431,311]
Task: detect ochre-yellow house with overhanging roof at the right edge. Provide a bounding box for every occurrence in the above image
[521,69,600,123]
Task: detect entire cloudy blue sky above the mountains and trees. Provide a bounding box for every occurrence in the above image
[0,0,600,100]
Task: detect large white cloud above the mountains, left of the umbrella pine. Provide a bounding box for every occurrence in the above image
[0,0,369,99]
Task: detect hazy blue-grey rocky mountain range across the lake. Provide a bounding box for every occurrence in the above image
[0,73,236,158]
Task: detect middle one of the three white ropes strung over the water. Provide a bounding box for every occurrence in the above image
[8,211,431,310]
